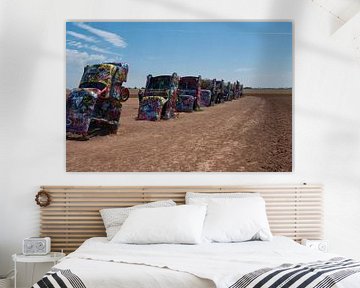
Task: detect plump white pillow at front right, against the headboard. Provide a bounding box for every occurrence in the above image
[203,197,272,242]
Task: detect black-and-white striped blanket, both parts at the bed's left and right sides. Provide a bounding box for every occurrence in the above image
[32,258,360,288]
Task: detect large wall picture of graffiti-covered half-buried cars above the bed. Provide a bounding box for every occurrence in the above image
[64,21,293,172]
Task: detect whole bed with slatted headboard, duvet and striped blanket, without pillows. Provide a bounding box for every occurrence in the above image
[33,185,360,288]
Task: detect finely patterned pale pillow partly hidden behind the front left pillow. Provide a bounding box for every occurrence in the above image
[100,200,176,240]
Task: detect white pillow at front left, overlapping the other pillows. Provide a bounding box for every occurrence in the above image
[111,205,206,244]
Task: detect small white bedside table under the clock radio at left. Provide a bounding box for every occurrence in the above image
[12,252,65,288]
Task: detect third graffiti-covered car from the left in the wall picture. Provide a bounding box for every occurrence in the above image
[176,76,201,112]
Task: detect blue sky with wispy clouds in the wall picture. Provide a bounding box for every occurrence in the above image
[66,22,292,88]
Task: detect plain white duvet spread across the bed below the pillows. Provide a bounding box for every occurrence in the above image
[55,237,360,288]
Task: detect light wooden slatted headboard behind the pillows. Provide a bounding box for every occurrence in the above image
[40,185,323,252]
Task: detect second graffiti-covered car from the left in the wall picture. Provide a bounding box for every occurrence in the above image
[138,73,179,121]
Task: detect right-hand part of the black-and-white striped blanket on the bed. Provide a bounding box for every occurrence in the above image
[229,258,360,288]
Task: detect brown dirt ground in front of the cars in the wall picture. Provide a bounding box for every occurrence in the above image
[66,93,292,172]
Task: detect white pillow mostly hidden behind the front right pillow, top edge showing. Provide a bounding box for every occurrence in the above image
[185,192,260,204]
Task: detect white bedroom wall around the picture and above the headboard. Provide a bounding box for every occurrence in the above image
[0,0,360,284]
